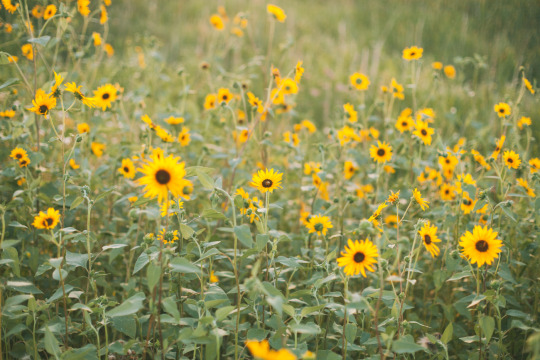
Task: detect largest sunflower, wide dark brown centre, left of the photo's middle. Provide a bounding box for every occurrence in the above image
[137,155,191,203]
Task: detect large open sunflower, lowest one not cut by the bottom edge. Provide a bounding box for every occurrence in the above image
[337,239,379,277]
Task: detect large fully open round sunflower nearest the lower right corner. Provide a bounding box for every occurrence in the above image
[459,225,503,267]
